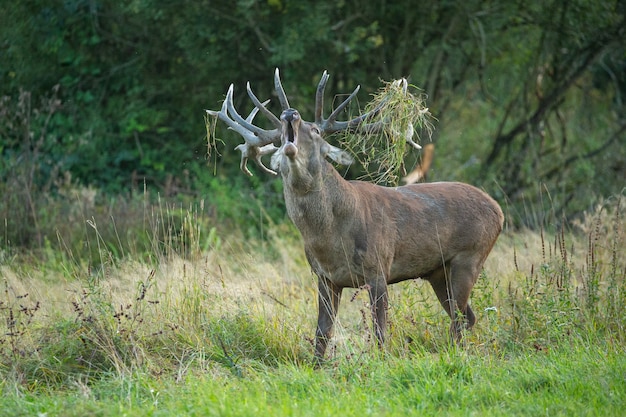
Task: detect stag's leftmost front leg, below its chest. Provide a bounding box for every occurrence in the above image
[315,277,342,366]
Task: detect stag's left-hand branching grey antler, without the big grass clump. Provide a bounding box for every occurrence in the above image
[206,83,280,176]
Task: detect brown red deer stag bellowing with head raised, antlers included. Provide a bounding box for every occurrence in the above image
[207,69,504,363]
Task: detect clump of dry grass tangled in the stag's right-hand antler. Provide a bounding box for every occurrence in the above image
[339,79,434,185]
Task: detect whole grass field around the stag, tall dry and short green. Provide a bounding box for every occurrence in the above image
[0,193,626,416]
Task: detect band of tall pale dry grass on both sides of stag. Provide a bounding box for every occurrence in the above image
[0,187,626,389]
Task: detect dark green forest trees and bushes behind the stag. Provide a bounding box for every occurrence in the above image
[0,0,626,252]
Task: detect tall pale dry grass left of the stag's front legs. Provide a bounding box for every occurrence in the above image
[0,188,307,389]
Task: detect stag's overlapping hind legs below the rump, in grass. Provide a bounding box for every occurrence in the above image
[428,260,480,343]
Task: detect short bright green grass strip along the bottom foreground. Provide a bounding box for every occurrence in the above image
[0,346,626,416]
